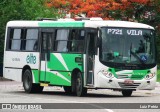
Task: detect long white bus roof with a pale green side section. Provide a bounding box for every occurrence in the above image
[7,20,154,29]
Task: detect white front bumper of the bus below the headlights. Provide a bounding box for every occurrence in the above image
[97,75,156,90]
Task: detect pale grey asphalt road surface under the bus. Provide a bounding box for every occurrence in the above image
[0,81,160,112]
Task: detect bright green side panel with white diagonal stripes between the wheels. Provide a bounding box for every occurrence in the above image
[32,53,83,86]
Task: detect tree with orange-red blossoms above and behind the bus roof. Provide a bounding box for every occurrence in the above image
[46,0,150,19]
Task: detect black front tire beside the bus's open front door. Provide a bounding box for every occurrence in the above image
[76,72,87,97]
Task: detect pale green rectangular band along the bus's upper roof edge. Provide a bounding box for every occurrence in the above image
[38,22,84,27]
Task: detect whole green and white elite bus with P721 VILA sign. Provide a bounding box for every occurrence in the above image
[3,18,157,96]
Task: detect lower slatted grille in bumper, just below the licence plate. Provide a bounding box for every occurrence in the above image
[118,82,141,89]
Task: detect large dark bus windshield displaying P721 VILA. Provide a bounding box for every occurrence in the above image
[100,27,155,68]
